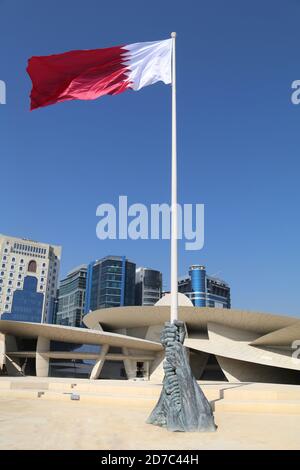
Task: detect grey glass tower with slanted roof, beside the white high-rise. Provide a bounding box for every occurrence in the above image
[55,265,87,327]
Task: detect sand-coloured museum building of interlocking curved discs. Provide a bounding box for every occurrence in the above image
[0,294,300,384]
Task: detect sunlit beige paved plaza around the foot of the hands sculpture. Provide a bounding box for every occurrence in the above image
[0,377,300,450]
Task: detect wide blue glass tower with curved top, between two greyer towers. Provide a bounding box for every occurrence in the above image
[85,256,136,313]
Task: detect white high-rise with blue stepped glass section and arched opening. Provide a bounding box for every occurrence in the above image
[0,235,61,323]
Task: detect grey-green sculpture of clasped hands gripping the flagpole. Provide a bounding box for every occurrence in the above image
[147,321,217,432]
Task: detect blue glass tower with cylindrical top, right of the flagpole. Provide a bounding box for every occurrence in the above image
[178,264,231,308]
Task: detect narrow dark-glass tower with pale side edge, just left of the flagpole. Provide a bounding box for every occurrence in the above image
[135,267,162,305]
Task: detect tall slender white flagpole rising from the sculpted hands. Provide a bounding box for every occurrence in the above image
[171,33,178,323]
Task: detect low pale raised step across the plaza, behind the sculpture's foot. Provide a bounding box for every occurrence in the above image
[0,377,300,414]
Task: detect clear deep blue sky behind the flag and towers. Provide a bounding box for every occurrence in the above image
[0,0,300,315]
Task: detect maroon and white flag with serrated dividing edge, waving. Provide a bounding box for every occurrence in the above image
[27,39,172,109]
